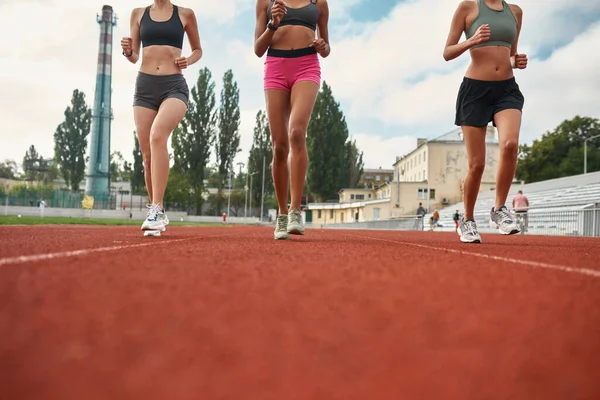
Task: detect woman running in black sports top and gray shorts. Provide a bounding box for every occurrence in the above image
[121,0,202,236]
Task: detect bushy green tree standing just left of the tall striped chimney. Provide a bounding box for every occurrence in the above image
[54,89,92,191]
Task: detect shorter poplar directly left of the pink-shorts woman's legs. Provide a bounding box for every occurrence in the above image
[248,111,275,207]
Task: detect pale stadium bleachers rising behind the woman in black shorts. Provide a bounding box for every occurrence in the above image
[424,172,600,235]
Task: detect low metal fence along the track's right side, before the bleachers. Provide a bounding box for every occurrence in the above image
[313,207,600,237]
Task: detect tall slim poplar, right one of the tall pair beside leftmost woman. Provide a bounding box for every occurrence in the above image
[216,70,240,212]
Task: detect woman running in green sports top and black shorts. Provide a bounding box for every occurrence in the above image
[444,0,527,243]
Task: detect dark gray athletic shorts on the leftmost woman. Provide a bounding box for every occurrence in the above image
[133,72,190,111]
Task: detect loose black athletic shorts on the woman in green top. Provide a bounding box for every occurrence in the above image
[454,76,525,127]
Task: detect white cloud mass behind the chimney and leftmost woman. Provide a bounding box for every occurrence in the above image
[0,0,260,170]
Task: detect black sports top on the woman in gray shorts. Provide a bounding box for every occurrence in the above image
[140,5,185,49]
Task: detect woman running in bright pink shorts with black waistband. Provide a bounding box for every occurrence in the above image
[254,0,331,240]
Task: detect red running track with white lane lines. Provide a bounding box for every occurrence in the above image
[0,226,600,400]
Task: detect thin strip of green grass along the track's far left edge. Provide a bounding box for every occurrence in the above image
[0,215,222,226]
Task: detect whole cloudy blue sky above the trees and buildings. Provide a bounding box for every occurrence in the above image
[0,0,600,173]
